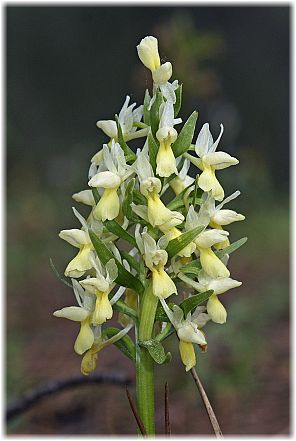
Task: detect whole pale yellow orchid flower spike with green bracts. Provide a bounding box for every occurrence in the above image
[54,36,246,430]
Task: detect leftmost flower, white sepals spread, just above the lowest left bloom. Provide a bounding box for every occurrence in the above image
[53,279,94,355]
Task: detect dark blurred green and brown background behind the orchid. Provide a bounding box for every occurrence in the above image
[6,6,290,435]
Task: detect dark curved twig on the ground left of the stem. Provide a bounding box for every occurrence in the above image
[6,373,131,421]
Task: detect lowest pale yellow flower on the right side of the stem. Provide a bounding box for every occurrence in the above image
[160,299,208,372]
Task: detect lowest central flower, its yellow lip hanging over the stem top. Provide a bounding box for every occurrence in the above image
[135,224,177,299]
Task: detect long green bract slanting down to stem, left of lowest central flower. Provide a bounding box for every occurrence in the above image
[88,229,144,294]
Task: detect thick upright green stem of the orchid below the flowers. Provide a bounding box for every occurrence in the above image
[136,281,158,435]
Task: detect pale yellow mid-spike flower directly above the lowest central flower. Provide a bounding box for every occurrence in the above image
[133,150,184,227]
